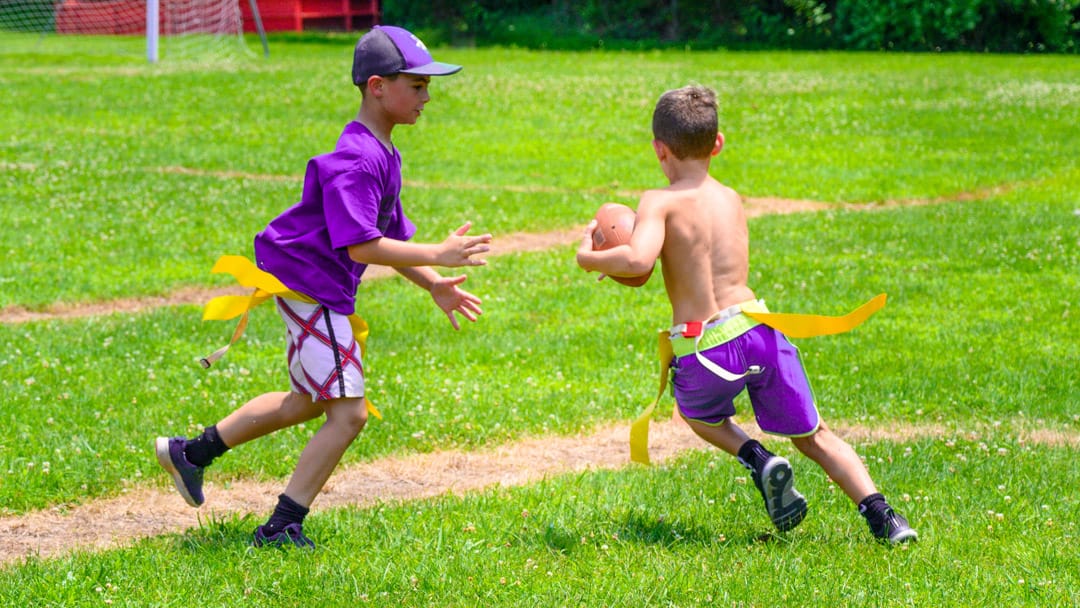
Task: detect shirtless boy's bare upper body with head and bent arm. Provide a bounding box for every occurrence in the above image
[578,86,754,325]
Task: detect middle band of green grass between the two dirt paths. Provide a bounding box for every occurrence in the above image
[0,184,1080,511]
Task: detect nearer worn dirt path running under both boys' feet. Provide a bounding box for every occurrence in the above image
[0,421,1080,565]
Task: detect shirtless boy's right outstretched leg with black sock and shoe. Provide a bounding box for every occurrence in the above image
[792,422,918,543]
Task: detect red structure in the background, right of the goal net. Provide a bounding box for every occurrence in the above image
[239,0,381,32]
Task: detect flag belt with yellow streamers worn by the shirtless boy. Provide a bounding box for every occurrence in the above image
[630,294,886,464]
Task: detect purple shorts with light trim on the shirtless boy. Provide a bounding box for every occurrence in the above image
[672,325,820,437]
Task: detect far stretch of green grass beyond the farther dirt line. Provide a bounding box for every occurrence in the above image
[0,37,1080,309]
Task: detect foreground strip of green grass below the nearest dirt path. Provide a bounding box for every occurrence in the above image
[0,444,1080,607]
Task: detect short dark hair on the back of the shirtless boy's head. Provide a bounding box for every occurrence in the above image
[652,85,719,160]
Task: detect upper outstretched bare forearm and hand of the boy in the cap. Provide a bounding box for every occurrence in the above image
[349,222,491,268]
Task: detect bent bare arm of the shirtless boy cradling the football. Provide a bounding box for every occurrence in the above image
[578,192,664,276]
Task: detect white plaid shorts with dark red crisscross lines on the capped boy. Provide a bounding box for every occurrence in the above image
[274,297,364,401]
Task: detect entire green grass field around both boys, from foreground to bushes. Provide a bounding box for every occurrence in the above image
[0,35,1080,607]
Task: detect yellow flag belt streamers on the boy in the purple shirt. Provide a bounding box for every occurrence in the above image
[199,256,382,419]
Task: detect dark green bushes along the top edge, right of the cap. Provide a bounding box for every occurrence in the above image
[383,0,1080,53]
